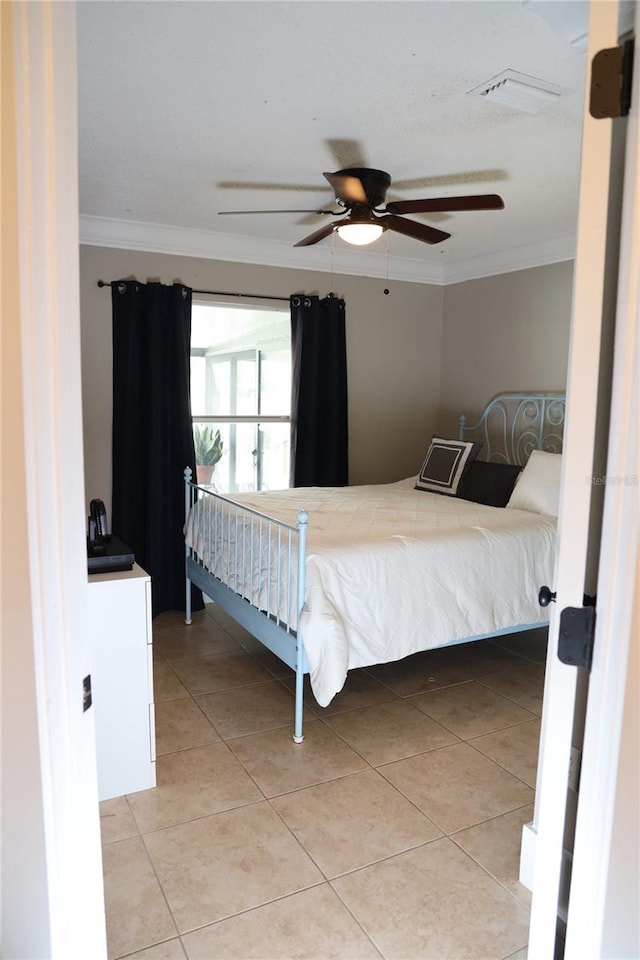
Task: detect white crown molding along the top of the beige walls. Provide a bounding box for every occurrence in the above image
[80,215,575,286]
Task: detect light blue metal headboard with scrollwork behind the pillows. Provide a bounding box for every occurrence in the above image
[458,392,566,466]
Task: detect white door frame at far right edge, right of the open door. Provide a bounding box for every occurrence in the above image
[565,4,640,960]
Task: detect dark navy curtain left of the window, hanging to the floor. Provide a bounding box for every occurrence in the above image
[111,280,203,616]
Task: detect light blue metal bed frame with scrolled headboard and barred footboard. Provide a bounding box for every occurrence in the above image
[184,392,565,743]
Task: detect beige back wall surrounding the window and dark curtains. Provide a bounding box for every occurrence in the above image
[80,246,442,504]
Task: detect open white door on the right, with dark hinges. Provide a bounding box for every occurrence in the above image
[523,0,637,960]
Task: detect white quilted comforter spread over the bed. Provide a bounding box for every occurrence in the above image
[187,479,556,706]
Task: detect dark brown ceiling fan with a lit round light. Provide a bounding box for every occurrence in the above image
[220,167,504,247]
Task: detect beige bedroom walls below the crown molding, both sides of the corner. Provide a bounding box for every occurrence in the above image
[80,246,573,504]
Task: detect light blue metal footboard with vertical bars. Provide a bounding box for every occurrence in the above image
[184,467,309,743]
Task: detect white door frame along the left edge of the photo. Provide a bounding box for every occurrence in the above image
[2,0,106,960]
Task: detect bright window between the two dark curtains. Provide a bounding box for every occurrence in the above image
[191,301,291,493]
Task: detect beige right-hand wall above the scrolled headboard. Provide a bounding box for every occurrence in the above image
[439,261,573,436]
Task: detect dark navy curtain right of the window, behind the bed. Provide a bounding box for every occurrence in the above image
[290,294,349,487]
